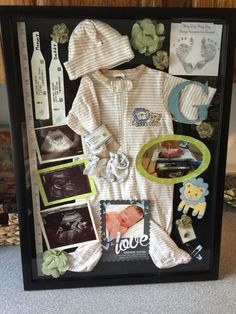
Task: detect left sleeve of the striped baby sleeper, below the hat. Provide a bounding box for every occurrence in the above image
[66,75,101,136]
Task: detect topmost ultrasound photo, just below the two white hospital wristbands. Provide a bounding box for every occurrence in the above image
[35,125,83,163]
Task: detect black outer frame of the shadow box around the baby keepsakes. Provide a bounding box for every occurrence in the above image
[0,7,236,290]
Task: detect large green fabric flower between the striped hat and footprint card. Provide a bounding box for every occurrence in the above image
[130,19,165,56]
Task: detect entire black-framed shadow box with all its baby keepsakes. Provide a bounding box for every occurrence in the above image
[1,7,236,290]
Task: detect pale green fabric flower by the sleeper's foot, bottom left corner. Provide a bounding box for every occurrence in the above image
[42,250,69,278]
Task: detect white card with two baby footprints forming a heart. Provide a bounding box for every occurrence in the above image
[169,22,222,76]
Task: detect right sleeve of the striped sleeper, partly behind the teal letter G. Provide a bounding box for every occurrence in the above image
[163,72,216,120]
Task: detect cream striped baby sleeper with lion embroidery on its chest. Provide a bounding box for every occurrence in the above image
[66,65,216,271]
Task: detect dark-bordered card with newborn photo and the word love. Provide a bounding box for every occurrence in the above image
[100,200,150,262]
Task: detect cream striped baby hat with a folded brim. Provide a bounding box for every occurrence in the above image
[64,19,134,80]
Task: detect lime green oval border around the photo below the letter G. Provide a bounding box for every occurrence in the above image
[135,134,211,184]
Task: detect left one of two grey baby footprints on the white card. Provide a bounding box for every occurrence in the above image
[175,37,193,73]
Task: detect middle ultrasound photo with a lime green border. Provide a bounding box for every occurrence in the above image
[36,161,96,206]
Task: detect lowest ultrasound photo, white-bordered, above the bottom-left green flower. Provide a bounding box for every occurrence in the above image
[40,203,98,249]
